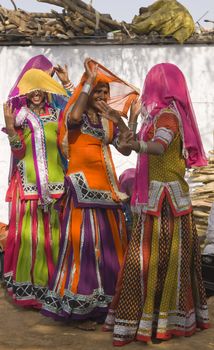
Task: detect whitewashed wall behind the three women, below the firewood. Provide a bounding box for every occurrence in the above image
[0,45,214,222]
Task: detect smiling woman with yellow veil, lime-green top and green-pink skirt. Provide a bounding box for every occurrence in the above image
[4,55,74,308]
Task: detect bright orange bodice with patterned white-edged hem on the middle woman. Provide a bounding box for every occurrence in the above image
[67,116,126,206]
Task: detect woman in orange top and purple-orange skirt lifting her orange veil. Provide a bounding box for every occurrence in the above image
[43,59,138,329]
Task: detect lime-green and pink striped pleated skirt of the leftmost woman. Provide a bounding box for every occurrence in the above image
[4,189,60,308]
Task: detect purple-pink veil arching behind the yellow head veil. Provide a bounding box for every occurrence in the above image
[8,55,53,109]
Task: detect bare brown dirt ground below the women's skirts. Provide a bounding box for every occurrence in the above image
[0,284,214,350]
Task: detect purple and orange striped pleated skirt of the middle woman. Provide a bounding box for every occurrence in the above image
[42,197,127,321]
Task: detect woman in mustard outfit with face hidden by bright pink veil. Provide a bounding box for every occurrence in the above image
[101,63,209,346]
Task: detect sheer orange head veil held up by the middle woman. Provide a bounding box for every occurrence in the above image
[59,60,140,156]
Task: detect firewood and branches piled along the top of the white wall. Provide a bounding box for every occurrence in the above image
[0,0,214,45]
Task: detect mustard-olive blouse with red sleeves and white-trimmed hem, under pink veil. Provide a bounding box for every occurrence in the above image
[146,110,192,216]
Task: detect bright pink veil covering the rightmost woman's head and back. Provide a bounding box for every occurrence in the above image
[132,63,207,205]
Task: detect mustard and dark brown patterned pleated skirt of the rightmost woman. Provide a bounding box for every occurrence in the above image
[104,199,209,346]
